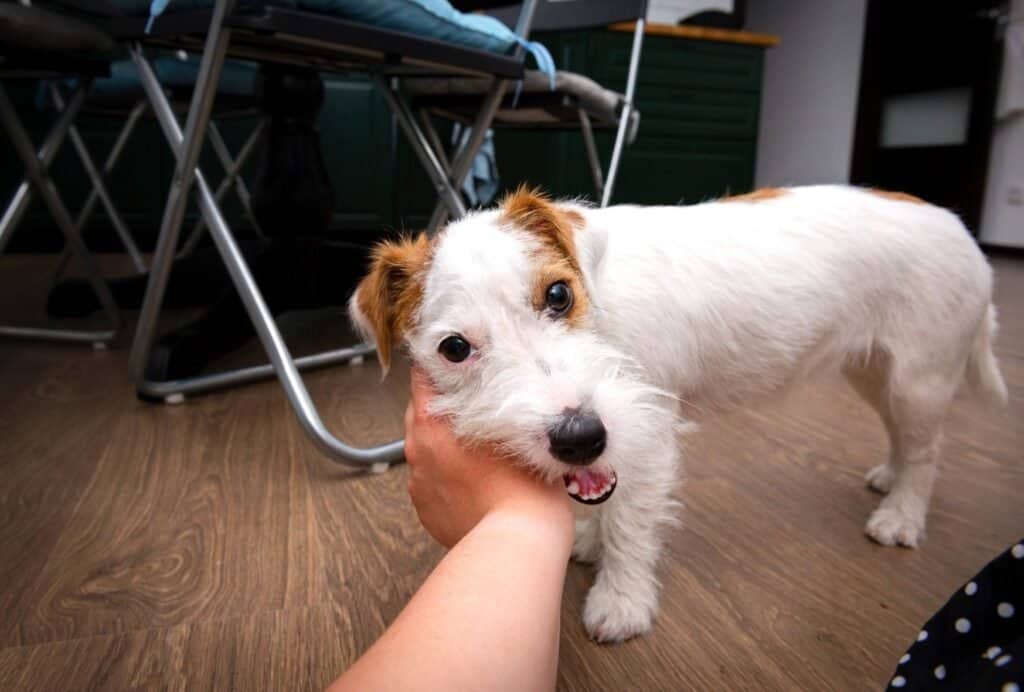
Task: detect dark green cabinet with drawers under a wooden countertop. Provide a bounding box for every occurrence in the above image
[497,31,764,204]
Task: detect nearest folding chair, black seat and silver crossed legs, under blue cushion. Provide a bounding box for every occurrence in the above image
[92,0,536,472]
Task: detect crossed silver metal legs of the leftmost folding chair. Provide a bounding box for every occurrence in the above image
[0,82,120,345]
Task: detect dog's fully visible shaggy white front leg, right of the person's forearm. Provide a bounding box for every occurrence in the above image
[583,452,679,643]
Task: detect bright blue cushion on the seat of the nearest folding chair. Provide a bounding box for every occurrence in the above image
[125,0,517,53]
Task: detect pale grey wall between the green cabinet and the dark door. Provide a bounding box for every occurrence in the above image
[746,0,867,186]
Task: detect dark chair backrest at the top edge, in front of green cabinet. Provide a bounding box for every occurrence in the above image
[453,0,647,32]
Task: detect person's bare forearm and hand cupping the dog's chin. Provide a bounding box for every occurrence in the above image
[329,370,573,692]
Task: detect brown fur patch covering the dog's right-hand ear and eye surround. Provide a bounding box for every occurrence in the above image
[501,186,590,327]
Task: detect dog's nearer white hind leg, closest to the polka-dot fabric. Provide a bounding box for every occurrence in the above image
[865,359,963,548]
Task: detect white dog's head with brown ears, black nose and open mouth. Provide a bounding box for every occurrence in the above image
[349,190,666,503]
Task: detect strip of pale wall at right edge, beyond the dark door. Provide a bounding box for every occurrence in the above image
[981,0,1024,248]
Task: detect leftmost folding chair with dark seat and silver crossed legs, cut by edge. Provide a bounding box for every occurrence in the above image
[0,3,120,348]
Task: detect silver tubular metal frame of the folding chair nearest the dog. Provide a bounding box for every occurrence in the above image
[113,0,536,472]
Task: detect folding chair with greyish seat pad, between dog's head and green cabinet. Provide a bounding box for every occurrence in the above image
[404,0,647,230]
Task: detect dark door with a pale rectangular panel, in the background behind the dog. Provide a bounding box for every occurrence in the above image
[850,0,1006,232]
